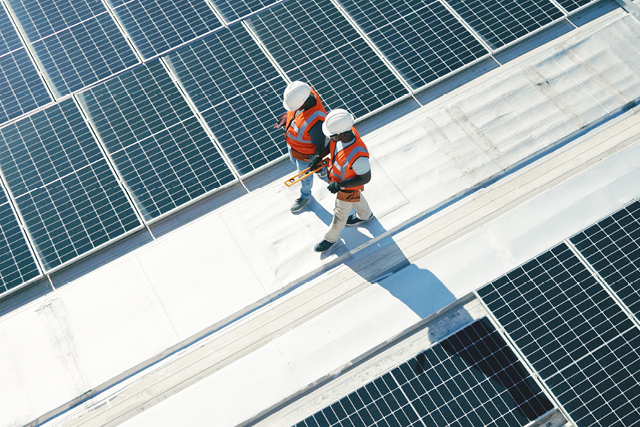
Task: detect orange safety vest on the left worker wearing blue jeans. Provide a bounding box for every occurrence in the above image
[284,89,327,156]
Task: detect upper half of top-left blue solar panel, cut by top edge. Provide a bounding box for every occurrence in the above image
[7,0,106,42]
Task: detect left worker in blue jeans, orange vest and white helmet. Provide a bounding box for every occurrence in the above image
[274,81,327,213]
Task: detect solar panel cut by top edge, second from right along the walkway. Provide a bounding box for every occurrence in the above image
[447,0,564,49]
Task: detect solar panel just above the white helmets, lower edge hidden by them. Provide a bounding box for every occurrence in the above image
[247,0,408,117]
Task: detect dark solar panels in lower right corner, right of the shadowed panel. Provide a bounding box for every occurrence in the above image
[478,202,640,427]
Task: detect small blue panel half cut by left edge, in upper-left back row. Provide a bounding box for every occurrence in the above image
[0,48,51,123]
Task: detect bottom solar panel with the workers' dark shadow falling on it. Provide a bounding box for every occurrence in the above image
[296,318,553,427]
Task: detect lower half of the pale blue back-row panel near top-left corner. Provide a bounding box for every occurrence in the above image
[33,13,138,96]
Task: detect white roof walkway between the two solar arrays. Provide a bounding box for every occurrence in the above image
[0,5,640,427]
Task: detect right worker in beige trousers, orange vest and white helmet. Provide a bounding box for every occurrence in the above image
[311,108,373,252]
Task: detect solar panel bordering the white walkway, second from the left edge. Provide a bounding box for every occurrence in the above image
[0,99,140,270]
